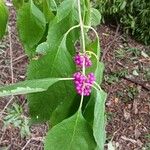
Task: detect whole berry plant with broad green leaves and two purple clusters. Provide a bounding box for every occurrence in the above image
[0,0,106,150]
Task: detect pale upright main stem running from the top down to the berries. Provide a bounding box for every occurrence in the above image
[78,0,86,75]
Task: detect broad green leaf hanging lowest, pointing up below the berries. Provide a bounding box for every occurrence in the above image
[45,111,96,150]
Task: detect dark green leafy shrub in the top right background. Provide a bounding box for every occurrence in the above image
[94,0,150,45]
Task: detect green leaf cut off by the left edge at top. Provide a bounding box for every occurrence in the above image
[0,0,8,39]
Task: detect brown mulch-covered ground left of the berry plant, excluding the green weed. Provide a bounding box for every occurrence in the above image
[0,4,48,150]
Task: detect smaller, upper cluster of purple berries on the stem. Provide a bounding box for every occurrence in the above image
[74,54,92,67]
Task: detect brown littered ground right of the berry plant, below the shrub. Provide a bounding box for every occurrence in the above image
[98,26,150,150]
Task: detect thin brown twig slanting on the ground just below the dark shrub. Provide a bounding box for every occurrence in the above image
[101,24,120,61]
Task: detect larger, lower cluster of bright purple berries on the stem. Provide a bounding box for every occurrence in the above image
[73,72,95,96]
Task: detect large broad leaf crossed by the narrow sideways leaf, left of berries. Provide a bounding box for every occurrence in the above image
[28,26,76,121]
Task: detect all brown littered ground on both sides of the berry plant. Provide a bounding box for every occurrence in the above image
[0,2,150,150]
